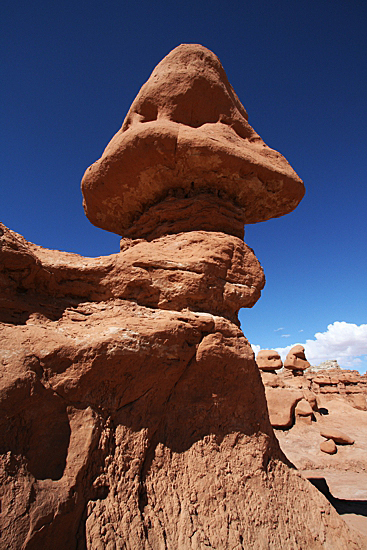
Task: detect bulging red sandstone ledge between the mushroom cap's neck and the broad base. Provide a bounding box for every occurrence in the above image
[0,225,265,328]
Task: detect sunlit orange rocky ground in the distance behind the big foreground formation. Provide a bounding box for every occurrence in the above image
[262,362,367,534]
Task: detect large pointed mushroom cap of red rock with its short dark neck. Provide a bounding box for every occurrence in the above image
[82,44,304,240]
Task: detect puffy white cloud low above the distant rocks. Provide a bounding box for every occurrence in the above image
[275,321,367,374]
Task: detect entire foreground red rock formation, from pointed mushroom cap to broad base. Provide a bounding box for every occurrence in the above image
[0,45,364,550]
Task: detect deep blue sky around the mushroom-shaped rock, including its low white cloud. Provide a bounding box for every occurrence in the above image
[0,0,367,371]
